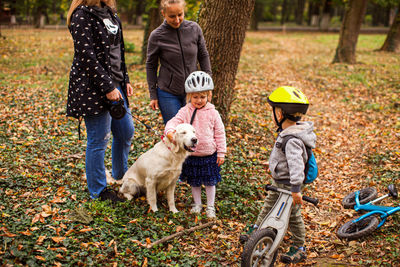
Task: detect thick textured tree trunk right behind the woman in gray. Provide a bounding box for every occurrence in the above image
[199,0,255,122]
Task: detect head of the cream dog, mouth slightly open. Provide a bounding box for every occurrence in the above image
[174,123,197,152]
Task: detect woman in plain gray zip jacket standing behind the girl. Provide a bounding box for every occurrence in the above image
[146,0,211,124]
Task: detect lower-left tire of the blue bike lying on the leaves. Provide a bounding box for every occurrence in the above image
[336,216,379,240]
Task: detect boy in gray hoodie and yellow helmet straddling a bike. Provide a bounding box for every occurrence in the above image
[242,86,316,263]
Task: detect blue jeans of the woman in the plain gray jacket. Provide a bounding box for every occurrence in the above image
[157,88,186,124]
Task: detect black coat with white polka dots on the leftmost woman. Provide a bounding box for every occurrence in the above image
[67,6,129,118]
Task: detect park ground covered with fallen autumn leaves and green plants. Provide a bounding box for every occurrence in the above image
[0,30,400,266]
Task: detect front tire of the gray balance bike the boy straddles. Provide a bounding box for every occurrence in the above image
[241,229,278,267]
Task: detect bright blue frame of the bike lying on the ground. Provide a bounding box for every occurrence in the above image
[353,191,400,228]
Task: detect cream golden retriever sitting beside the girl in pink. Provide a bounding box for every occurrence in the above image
[119,123,197,213]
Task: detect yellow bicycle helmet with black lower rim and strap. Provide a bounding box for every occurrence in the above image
[268,86,310,131]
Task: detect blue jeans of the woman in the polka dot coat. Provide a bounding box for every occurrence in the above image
[84,87,135,198]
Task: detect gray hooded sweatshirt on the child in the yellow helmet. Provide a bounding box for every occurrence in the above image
[269,121,317,193]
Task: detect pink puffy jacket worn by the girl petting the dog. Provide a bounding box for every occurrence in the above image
[164,103,226,158]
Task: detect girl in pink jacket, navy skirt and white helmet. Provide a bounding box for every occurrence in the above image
[165,71,226,218]
